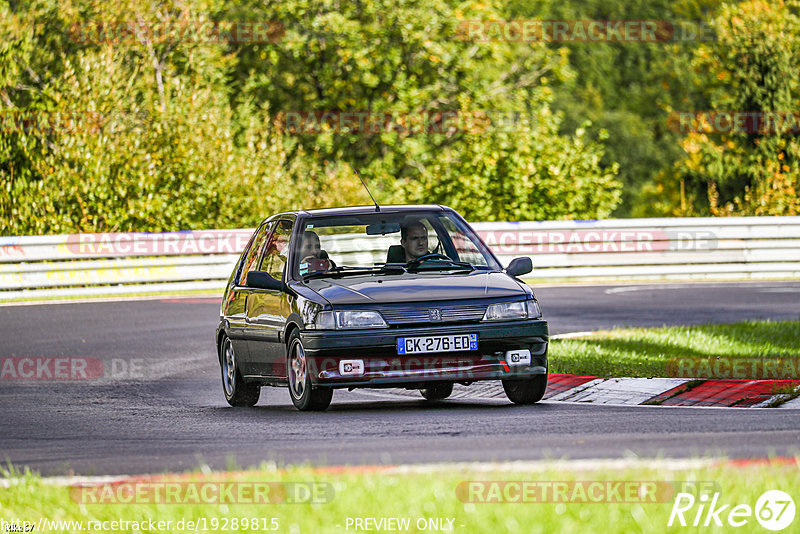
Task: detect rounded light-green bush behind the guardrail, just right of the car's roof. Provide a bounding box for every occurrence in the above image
[413,116,619,221]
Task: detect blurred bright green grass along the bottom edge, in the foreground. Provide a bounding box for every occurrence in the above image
[0,463,800,534]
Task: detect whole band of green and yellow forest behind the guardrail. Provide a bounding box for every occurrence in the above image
[0,0,800,235]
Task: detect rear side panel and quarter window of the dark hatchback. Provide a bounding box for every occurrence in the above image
[225,221,275,375]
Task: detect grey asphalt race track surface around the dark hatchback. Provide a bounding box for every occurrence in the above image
[0,282,800,474]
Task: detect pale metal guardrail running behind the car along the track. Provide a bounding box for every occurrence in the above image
[0,217,800,299]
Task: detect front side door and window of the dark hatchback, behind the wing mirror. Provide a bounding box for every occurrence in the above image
[247,217,294,377]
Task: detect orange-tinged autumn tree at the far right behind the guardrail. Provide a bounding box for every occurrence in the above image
[681,1,800,215]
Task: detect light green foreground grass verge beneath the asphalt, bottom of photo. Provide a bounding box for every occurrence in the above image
[0,462,800,534]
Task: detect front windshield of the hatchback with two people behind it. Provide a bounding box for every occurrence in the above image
[294,211,501,278]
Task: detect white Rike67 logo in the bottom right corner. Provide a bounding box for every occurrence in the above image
[667,490,795,532]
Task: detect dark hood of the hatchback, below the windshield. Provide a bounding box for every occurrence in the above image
[306,271,527,305]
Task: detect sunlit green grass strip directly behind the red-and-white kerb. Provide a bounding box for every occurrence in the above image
[549,321,800,378]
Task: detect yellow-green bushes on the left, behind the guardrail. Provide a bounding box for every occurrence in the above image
[0,1,328,234]
